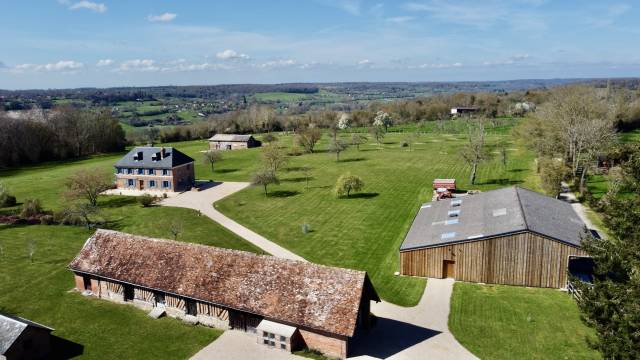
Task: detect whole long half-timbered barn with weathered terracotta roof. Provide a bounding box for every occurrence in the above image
[69,230,380,358]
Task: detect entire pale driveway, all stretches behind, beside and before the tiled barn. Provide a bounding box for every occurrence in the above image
[161,182,477,360]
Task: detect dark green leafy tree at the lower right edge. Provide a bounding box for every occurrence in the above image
[574,153,640,359]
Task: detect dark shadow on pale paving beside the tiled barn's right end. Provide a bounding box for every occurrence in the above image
[349,317,440,359]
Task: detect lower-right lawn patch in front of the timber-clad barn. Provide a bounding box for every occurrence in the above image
[449,283,600,359]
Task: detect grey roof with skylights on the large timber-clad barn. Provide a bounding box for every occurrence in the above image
[400,187,586,250]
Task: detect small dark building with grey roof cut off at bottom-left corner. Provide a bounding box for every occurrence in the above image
[0,314,53,360]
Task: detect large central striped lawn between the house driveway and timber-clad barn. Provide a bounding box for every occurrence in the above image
[215,128,537,305]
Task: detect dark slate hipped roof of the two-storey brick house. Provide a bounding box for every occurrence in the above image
[115,146,195,169]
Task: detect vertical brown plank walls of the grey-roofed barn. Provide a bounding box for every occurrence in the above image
[400,232,586,288]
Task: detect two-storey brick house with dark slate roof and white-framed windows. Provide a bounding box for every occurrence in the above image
[115,146,195,193]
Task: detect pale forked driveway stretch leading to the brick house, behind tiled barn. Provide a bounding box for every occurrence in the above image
[160,182,306,261]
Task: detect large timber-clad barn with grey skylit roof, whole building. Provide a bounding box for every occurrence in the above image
[400,187,586,288]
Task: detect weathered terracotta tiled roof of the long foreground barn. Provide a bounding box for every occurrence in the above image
[69,230,379,336]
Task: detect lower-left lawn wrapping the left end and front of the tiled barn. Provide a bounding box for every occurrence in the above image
[0,225,222,359]
